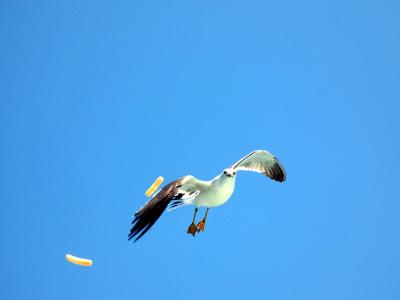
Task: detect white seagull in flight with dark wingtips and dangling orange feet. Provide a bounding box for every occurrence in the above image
[128,150,286,242]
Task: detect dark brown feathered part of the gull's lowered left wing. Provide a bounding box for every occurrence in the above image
[128,176,190,242]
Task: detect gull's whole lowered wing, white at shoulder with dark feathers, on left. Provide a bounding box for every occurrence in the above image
[128,175,201,242]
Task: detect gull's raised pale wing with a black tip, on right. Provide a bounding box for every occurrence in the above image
[231,150,286,182]
